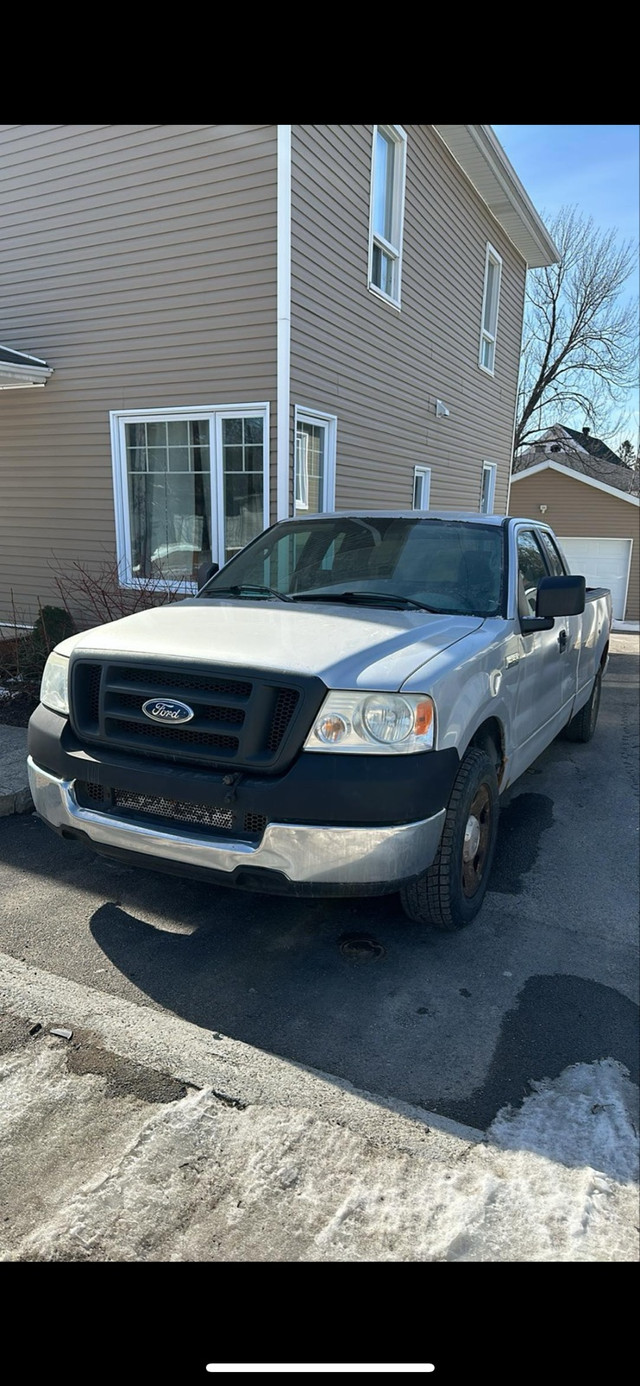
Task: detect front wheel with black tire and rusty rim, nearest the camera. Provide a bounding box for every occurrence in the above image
[400,747,500,930]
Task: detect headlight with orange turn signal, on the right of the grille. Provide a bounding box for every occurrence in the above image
[305,693,435,755]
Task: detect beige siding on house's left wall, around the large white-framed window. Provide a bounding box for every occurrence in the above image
[0,125,277,621]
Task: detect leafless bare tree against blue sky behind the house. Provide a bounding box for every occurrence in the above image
[514,207,637,452]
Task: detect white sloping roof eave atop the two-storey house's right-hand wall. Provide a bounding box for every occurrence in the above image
[434,125,560,269]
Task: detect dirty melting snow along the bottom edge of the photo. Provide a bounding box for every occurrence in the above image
[0,1052,639,1261]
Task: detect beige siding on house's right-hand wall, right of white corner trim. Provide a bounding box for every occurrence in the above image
[291,125,525,513]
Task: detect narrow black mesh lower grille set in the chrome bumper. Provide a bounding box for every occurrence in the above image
[75,780,267,839]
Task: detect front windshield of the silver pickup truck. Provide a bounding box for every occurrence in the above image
[198,516,503,615]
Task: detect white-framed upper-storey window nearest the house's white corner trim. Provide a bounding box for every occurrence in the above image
[368,125,407,308]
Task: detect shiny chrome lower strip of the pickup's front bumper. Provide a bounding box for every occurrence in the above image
[28,757,445,886]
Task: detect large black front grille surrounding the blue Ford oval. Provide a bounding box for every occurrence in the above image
[71,658,326,771]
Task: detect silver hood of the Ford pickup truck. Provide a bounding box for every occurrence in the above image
[57,597,482,690]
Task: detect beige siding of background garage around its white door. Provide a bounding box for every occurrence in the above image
[508,468,640,621]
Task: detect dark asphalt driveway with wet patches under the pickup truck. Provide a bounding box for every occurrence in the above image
[0,635,639,1130]
